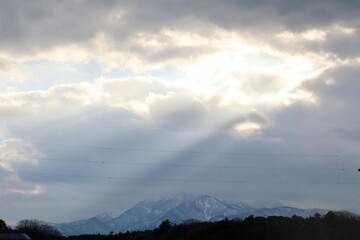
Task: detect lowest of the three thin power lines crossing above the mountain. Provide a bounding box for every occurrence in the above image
[0,170,360,185]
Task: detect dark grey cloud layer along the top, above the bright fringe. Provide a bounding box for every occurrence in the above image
[0,0,360,57]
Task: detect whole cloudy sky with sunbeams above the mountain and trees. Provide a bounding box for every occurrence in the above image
[0,0,360,224]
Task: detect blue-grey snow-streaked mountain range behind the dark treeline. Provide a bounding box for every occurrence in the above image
[53,194,328,236]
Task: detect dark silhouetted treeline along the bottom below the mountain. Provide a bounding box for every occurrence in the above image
[0,212,360,240]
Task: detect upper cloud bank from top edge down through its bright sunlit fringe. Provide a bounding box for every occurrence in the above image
[0,0,358,75]
